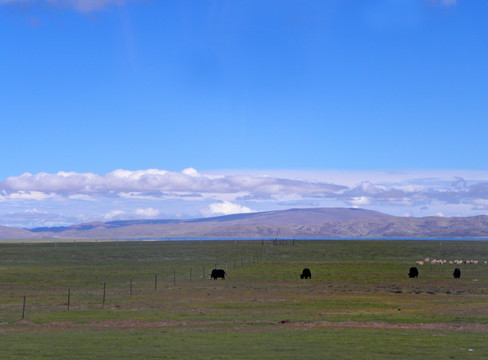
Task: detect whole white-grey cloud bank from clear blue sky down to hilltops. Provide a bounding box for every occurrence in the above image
[0,168,488,227]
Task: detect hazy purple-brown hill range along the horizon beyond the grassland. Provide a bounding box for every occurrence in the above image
[0,208,488,239]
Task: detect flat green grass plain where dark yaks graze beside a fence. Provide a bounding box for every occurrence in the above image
[0,240,488,359]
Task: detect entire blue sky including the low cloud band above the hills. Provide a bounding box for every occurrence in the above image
[0,0,488,226]
